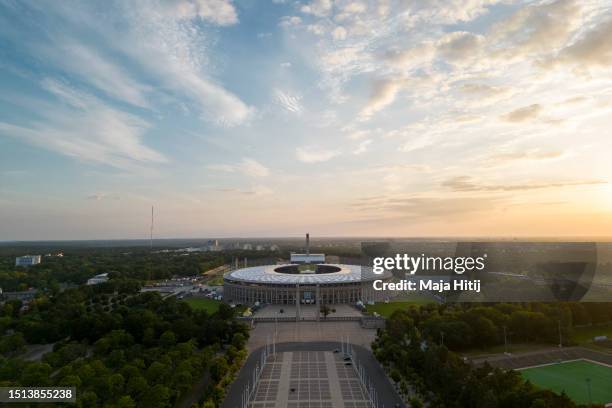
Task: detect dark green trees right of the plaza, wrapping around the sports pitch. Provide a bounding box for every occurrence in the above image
[372,303,612,408]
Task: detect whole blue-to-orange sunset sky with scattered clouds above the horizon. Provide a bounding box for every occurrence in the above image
[0,0,612,240]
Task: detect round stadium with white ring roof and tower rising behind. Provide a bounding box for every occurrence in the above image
[223,234,391,305]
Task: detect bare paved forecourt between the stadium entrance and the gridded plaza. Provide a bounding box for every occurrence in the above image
[247,321,376,352]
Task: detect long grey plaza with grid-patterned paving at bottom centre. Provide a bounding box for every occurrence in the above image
[249,351,369,408]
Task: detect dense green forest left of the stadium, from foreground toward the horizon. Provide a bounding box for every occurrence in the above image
[0,249,255,408]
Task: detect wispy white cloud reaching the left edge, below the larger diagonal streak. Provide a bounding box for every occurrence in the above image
[0,79,167,169]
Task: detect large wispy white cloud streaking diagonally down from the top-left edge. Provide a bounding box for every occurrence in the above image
[32,0,254,126]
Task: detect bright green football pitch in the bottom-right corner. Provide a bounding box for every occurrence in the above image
[519,360,612,404]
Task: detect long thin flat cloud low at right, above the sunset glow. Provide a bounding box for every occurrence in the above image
[442,176,607,192]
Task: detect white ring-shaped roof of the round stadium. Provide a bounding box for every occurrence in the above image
[225,264,389,285]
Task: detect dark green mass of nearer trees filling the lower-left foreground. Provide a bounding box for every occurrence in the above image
[0,280,248,408]
